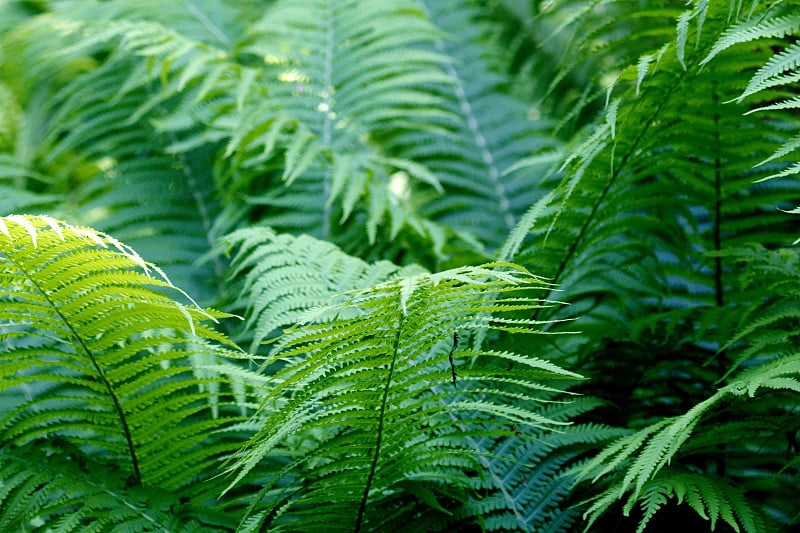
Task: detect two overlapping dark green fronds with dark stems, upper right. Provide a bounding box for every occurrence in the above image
[510,1,796,328]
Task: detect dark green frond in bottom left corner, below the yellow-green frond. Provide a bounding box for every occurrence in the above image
[0,440,236,533]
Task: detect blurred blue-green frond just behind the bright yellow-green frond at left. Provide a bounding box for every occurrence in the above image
[50,56,221,302]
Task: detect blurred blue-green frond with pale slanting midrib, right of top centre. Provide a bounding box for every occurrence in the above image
[382,1,560,249]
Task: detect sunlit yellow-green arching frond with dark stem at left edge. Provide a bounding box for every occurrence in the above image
[0,215,251,488]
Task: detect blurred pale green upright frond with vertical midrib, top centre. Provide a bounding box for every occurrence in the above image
[229,0,446,241]
